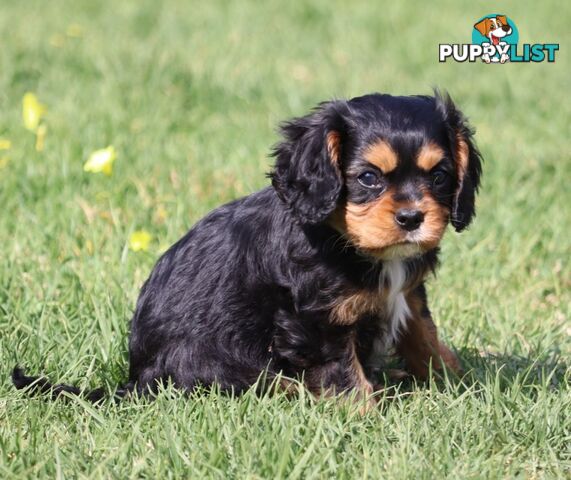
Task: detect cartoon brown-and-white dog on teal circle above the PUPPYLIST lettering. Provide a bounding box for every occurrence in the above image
[472,15,518,63]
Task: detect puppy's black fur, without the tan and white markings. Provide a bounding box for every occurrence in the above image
[13,94,481,400]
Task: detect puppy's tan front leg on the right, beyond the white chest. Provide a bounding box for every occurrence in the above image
[397,285,462,378]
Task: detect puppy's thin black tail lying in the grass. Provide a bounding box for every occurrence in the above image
[12,366,132,403]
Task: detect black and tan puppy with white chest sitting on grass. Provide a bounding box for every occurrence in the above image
[13,94,481,400]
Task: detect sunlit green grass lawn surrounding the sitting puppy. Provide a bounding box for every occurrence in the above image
[0,0,571,479]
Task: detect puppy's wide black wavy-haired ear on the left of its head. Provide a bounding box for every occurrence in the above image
[269,101,348,224]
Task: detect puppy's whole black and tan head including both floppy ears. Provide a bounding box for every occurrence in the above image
[270,93,481,259]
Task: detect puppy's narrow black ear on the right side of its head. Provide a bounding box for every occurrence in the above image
[434,91,482,232]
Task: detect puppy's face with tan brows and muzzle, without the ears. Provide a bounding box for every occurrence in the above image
[330,135,455,259]
